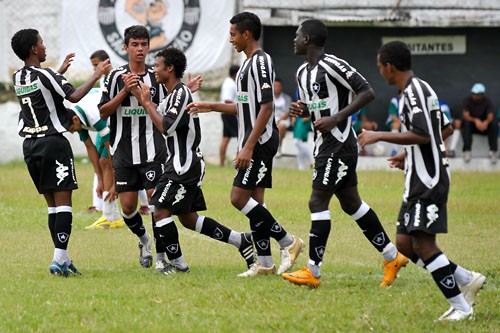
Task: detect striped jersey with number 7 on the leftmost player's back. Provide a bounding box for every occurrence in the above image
[13,66,75,138]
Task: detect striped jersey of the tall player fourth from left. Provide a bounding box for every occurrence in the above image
[236,50,279,159]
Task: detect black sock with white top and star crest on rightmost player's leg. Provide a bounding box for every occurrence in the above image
[424,252,460,299]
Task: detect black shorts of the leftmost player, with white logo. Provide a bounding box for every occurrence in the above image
[23,134,78,194]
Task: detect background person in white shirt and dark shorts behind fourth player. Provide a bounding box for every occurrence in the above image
[219,65,240,166]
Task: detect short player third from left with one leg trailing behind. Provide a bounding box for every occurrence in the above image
[132,48,255,275]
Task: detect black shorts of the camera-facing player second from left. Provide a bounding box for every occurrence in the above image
[115,163,164,193]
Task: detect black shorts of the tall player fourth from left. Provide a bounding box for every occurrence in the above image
[233,158,273,190]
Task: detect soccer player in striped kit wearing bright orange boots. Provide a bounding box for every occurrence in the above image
[282,20,408,288]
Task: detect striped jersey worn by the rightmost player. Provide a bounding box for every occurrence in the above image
[399,77,450,204]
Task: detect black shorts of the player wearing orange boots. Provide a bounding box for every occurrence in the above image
[313,156,358,193]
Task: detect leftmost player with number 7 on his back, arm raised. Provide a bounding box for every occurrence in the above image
[11,29,109,276]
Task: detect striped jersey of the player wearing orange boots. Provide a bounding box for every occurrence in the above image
[297,54,370,158]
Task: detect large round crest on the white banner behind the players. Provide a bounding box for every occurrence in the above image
[97,0,201,65]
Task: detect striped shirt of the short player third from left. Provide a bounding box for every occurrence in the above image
[158,83,205,186]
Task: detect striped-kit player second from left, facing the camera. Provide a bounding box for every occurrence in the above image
[99,25,201,268]
